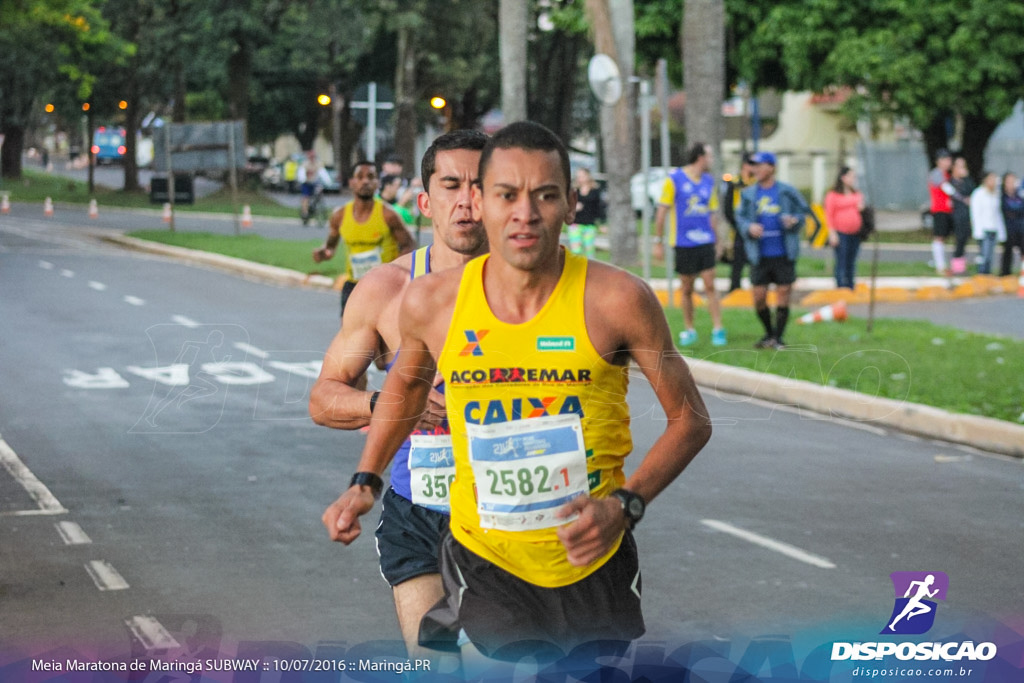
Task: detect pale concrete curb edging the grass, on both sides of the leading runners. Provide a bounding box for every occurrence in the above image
[105,233,1024,460]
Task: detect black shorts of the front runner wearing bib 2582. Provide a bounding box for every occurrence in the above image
[420,531,645,661]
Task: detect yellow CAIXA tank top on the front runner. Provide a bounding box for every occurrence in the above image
[438,252,633,588]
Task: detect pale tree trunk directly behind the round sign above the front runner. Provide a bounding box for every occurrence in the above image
[586,0,639,266]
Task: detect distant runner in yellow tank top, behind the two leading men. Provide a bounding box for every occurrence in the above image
[313,161,416,315]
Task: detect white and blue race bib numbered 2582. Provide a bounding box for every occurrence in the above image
[466,415,589,531]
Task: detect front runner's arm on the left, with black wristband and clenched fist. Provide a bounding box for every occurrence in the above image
[321,275,448,545]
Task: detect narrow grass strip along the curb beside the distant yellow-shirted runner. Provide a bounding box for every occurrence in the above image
[128,230,345,278]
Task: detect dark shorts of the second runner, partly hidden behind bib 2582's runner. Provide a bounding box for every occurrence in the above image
[376,486,449,586]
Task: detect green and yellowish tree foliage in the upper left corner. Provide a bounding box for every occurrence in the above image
[0,0,121,178]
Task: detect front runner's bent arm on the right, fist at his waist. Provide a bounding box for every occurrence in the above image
[558,272,711,566]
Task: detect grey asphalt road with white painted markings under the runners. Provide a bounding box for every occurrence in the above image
[0,217,1024,680]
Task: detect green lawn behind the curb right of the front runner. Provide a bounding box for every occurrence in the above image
[666,308,1024,423]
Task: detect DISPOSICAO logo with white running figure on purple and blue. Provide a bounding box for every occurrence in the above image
[831,571,996,661]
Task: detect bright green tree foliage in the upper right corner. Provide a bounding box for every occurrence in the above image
[731,0,1024,175]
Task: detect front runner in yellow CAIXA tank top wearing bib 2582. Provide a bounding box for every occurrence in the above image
[338,122,711,664]
